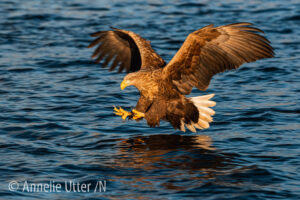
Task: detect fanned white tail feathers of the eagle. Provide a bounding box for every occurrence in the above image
[180,94,216,132]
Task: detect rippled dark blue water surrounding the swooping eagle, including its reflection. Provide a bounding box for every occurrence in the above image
[0,0,300,200]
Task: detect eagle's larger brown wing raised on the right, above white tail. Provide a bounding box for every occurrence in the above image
[163,23,274,94]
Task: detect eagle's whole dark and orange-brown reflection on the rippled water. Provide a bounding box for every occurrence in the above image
[109,134,235,191]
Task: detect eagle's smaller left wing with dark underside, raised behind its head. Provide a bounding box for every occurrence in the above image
[88,28,165,72]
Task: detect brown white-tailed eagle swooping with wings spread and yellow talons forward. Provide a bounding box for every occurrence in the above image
[88,23,274,132]
